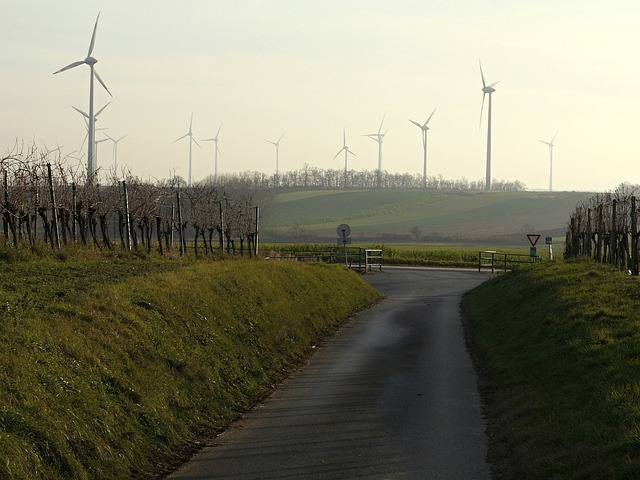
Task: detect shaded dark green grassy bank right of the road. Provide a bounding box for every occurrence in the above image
[464,262,640,479]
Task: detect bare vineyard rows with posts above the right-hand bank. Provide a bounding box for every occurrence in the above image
[565,184,640,275]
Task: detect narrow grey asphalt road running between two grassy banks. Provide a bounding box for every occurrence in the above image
[169,268,491,480]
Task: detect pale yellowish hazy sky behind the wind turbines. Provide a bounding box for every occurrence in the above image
[0,0,640,191]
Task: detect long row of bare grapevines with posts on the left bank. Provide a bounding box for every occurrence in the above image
[0,144,259,255]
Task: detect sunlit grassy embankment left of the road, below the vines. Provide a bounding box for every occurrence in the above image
[0,250,378,480]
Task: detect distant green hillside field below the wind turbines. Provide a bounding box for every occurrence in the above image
[262,189,591,242]
